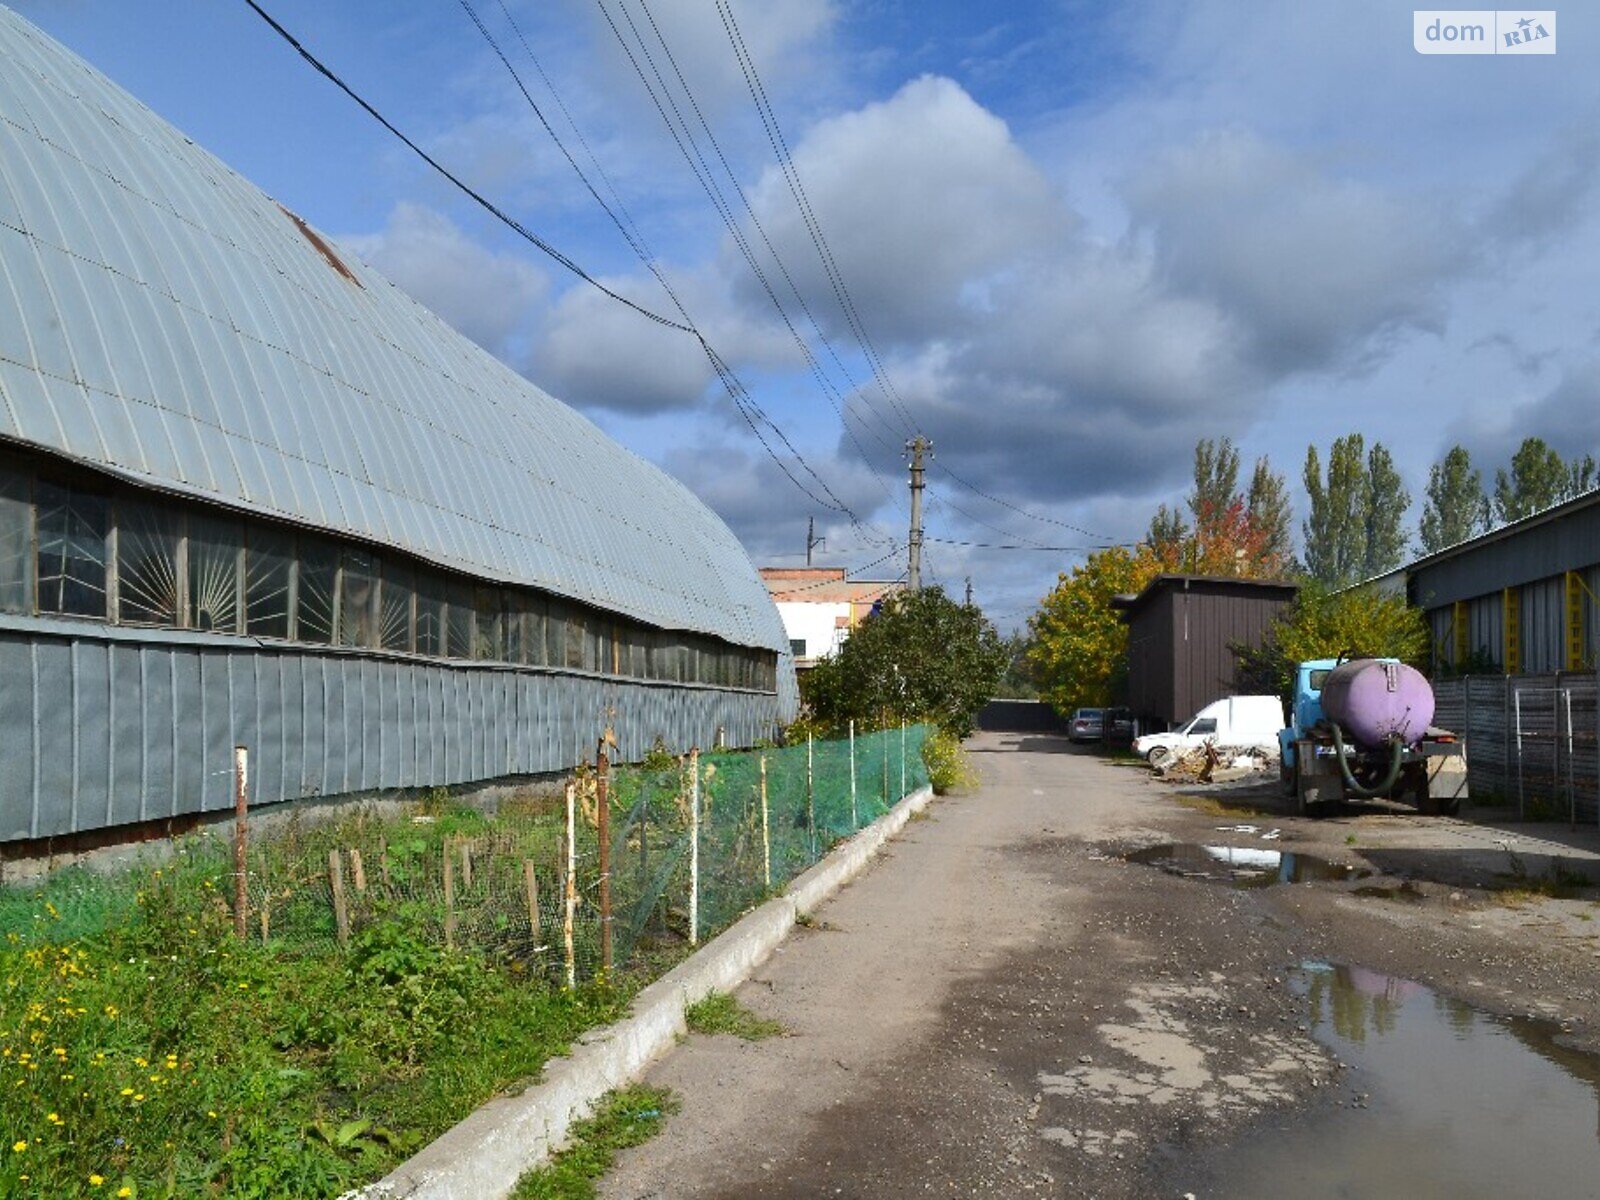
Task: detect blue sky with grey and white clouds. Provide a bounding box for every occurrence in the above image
[16,0,1600,626]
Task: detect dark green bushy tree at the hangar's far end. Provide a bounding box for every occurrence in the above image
[802,587,1008,738]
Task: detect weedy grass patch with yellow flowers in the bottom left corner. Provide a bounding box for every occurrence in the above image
[0,818,653,1200]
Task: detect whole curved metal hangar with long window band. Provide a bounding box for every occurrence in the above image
[0,8,795,843]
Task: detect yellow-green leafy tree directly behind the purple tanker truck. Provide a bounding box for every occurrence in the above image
[1234,581,1432,699]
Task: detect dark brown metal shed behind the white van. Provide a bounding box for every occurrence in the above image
[1112,574,1299,730]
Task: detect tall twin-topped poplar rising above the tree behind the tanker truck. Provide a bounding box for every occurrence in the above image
[1302,434,1411,587]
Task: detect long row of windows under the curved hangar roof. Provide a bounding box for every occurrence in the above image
[0,462,776,691]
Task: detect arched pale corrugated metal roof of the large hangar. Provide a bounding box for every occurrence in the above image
[0,8,787,650]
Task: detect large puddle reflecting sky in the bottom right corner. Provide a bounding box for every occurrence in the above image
[1171,963,1600,1200]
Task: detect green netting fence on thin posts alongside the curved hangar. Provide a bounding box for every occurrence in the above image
[0,725,928,982]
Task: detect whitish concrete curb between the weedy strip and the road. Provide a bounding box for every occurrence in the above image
[363,787,933,1200]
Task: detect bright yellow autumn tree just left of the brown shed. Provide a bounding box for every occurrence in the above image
[1029,547,1160,715]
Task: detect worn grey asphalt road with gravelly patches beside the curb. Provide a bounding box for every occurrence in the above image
[602,734,1600,1200]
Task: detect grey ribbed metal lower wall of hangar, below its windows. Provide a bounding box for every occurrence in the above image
[0,624,779,840]
